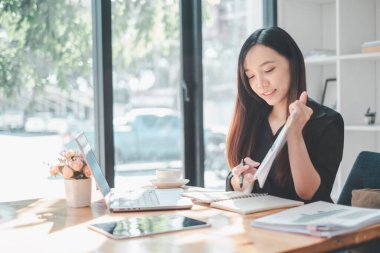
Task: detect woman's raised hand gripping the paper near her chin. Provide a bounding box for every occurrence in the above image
[287,91,313,136]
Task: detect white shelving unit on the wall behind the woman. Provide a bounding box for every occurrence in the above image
[277,0,380,202]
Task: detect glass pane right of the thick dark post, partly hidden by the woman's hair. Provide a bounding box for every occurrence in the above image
[202,0,262,188]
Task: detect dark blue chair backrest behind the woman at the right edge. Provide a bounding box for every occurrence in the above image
[337,151,380,206]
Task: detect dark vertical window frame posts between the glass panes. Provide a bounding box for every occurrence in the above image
[92,0,277,187]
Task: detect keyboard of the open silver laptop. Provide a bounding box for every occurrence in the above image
[119,190,159,207]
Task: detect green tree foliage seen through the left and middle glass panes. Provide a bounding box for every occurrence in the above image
[0,0,180,111]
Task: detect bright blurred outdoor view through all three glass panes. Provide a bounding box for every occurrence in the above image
[0,0,262,201]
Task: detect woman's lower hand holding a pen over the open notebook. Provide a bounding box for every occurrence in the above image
[231,157,260,191]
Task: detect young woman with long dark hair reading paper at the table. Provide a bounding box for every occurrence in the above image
[226,27,344,202]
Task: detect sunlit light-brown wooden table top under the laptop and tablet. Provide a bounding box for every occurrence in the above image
[0,196,380,253]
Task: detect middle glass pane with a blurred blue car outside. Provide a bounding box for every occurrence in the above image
[112,0,183,188]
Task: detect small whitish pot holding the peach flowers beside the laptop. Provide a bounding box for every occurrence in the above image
[64,178,91,207]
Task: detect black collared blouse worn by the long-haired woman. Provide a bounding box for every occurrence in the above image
[226,98,344,203]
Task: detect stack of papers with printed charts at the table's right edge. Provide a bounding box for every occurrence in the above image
[252,201,380,237]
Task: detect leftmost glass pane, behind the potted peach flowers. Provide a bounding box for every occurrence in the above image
[0,0,94,201]
